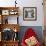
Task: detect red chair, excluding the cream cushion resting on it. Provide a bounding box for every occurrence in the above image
[21,28,41,46]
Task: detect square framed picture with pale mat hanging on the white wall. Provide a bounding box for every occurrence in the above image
[23,7,37,21]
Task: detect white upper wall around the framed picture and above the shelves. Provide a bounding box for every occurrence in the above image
[0,0,44,26]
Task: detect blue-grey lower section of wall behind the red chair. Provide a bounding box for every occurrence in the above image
[19,26,43,43]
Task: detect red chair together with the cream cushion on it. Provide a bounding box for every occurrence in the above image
[21,28,41,46]
